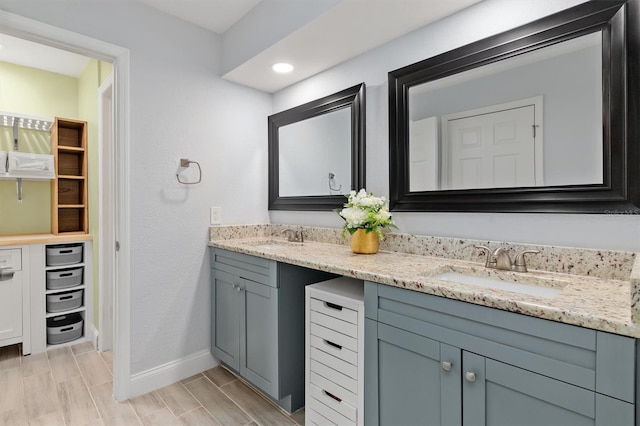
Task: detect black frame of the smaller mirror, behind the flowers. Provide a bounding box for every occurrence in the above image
[268,83,366,211]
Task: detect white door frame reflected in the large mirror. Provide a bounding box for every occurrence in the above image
[439,95,544,189]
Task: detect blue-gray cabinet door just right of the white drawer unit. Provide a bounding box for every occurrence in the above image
[364,320,462,426]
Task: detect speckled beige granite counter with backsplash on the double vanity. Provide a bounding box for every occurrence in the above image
[210,225,640,337]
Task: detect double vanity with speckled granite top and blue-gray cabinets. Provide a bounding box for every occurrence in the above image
[210,225,640,425]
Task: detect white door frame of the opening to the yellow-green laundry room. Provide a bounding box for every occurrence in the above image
[0,10,131,401]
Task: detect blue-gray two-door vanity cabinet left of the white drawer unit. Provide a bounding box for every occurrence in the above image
[211,248,335,412]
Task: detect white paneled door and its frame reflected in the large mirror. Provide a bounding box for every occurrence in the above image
[441,96,544,189]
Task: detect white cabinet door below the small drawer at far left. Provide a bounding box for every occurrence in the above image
[0,271,22,346]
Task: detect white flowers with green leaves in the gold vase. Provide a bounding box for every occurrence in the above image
[338,189,395,240]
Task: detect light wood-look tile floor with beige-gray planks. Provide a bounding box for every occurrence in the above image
[0,343,304,426]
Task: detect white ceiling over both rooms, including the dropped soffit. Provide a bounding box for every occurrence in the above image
[0,0,481,93]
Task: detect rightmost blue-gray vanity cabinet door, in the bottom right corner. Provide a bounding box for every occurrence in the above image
[462,352,634,426]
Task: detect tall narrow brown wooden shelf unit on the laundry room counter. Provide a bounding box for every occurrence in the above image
[51,117,89,235]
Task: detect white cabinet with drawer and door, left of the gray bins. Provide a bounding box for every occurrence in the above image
[0,247,31,355]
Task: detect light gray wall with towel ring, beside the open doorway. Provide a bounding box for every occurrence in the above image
[0,0,271,374]
